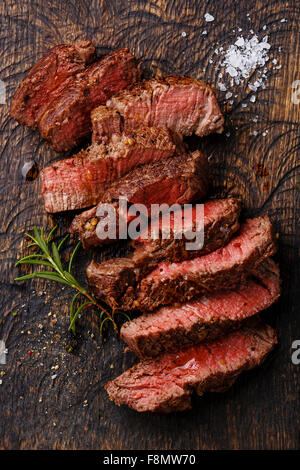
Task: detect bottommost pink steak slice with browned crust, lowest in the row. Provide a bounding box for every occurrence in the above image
[105,322,277,413]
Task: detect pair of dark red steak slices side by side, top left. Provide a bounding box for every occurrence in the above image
[10,47,141,152]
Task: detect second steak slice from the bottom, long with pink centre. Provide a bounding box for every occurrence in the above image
[121,259,280,358]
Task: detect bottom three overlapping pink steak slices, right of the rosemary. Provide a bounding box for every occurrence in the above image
[99,213,280,412]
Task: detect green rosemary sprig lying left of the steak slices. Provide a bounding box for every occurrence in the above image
[15,226,122,336]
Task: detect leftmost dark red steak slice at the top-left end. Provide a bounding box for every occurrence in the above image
[10,41,96,129]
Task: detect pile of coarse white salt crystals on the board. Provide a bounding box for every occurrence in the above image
[218,34,281,91]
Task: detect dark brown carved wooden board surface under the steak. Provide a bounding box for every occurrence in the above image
[0,0,300,449]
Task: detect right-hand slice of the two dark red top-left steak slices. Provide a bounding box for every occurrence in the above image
[38,49,140,152]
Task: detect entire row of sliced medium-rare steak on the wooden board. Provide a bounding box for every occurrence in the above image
[11,41,280,412]
